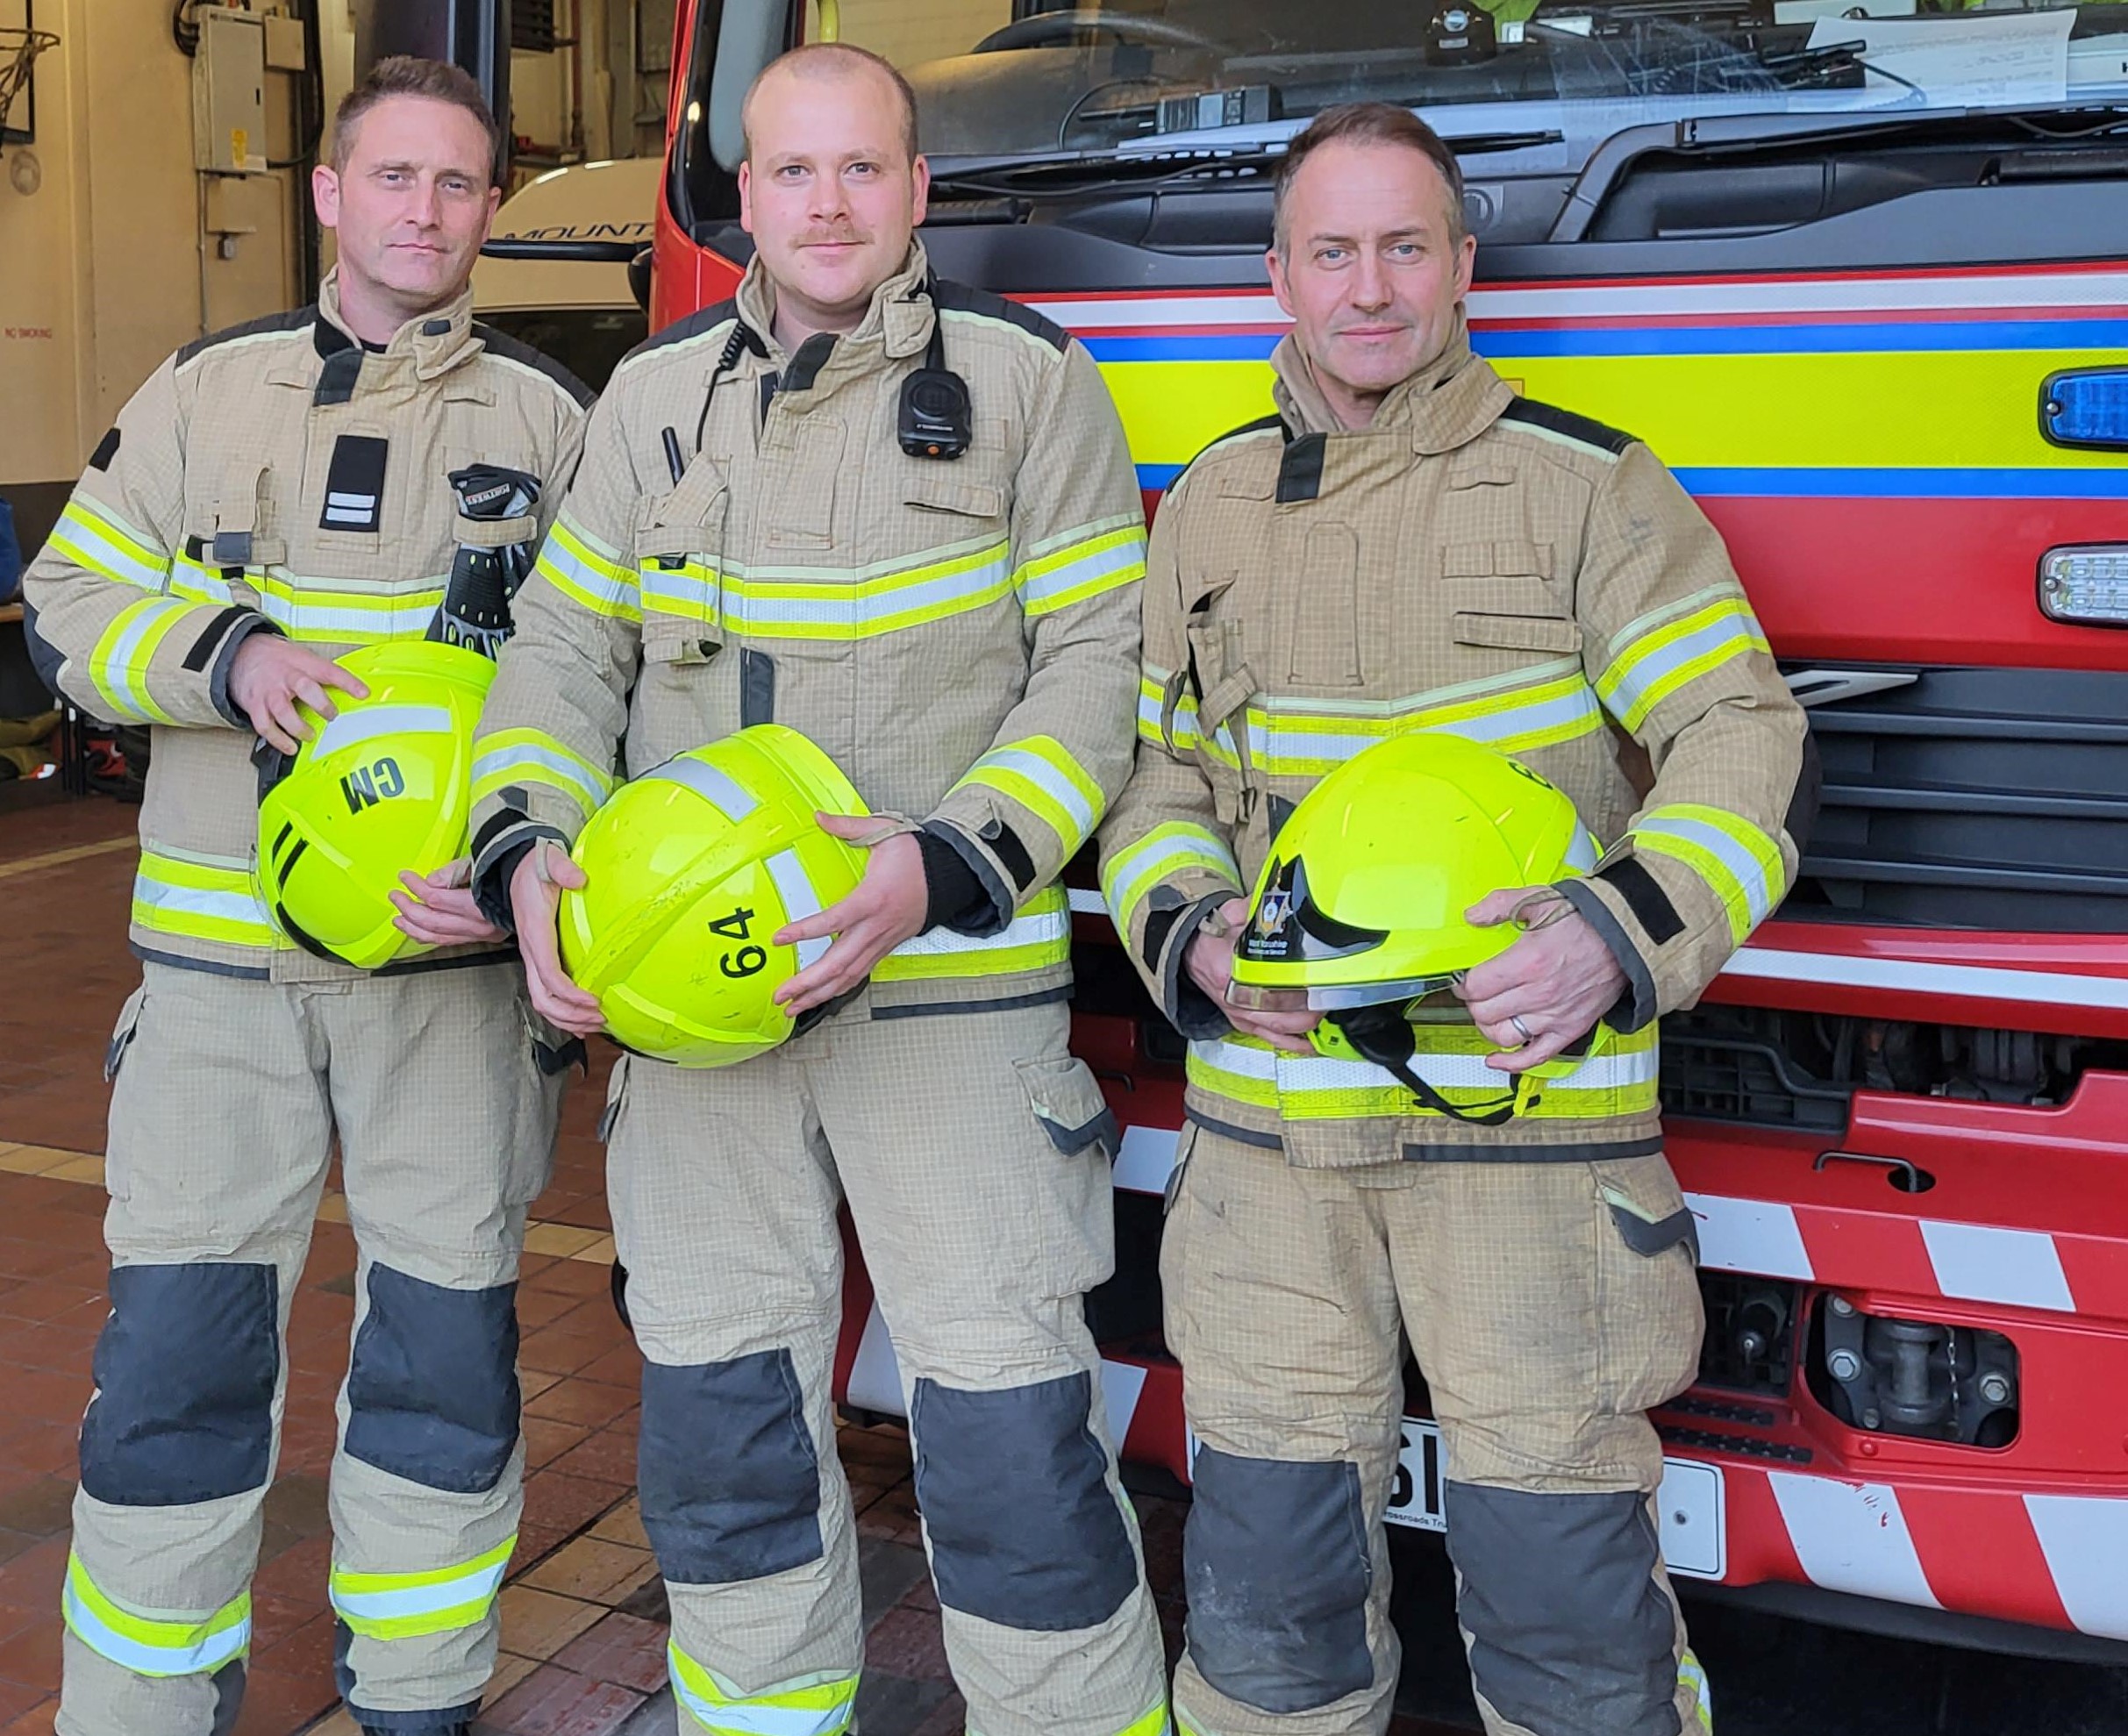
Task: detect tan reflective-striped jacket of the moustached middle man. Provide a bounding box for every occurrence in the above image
[475,245,1145,1012]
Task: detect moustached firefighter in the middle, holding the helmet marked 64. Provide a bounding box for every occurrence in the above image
[475,45,1166,1736]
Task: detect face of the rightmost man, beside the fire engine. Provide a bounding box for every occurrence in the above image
[1270,140,1477,425]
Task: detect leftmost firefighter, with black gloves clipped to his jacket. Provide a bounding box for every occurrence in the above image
[28,60,589,1736]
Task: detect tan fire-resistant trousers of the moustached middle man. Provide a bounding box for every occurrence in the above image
[609,1000,1166,1736]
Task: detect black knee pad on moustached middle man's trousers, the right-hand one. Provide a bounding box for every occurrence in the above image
[909,1372,1139,1634]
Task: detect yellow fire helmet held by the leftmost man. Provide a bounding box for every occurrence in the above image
[255,640,496,970]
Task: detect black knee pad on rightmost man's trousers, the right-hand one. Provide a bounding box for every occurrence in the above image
[1443,1481,1679,1736]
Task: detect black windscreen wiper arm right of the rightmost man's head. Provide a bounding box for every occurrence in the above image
[1545,101,2128,242]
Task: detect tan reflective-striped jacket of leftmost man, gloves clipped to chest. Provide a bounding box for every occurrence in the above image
[24,276,589,981]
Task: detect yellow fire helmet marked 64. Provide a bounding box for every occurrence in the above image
[561,724,868,1068]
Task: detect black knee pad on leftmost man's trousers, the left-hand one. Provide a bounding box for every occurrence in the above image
[81,1261,281,1506]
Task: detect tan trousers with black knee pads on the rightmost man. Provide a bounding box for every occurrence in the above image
[1162,1127,1711,1736]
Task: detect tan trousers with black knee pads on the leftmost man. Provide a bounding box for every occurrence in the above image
[58,960,561,1736]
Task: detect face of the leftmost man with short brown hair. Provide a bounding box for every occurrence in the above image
[311,96,503,317]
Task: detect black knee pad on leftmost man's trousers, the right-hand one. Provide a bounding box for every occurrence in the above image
[346,1264,518,1496]
